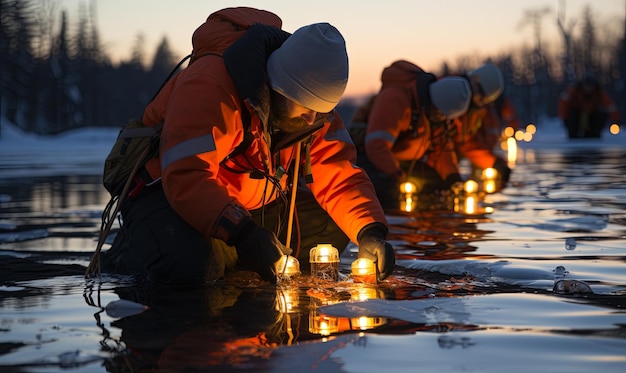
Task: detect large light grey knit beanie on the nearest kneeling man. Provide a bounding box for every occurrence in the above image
[267,23,348,113]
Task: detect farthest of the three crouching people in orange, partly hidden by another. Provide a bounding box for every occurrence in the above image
[454,63,511,187]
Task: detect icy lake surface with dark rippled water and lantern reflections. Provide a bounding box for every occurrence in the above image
[0,122,626,373]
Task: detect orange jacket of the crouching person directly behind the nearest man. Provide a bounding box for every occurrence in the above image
[365,60,458,179]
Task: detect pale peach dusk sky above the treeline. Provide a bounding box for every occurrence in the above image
[57,0,626,96]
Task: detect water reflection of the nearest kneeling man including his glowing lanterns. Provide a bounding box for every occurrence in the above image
[98,283,394,372]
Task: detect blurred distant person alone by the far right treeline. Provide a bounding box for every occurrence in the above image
[558,75,620,139]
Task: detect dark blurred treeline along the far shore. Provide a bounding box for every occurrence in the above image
[0,0,626,136]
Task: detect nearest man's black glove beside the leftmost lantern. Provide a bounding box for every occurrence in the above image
[233,219,292,284]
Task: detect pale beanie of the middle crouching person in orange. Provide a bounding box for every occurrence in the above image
[428,76,472,119]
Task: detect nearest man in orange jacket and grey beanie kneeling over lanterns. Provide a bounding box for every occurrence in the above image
[103,7,395,283]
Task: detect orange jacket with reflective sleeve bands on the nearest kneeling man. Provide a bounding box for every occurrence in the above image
[143,8,386,242]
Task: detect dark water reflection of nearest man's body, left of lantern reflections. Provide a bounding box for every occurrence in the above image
[102,286,279,371]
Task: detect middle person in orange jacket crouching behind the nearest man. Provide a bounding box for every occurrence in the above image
[351,60,471,209]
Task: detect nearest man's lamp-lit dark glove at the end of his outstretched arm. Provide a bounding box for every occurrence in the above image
[357,223,396,280]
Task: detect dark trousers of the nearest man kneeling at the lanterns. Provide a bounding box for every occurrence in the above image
[102,186,349,284]
